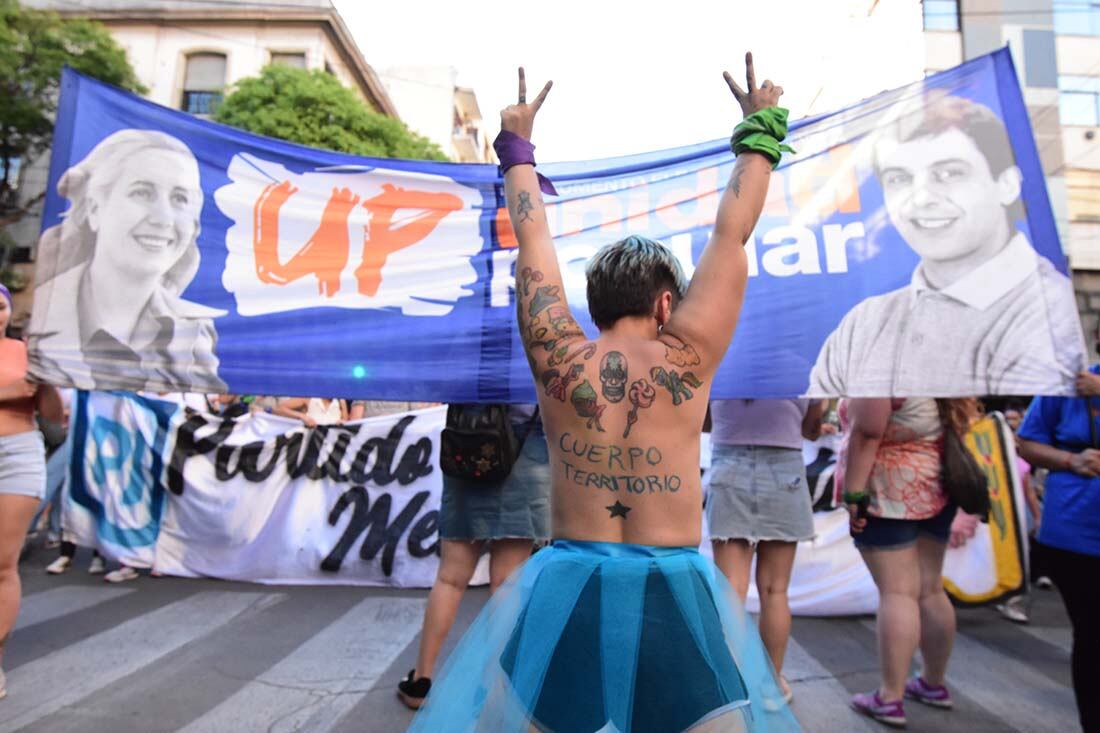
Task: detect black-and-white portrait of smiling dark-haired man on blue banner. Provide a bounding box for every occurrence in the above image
[807,96,1086,397]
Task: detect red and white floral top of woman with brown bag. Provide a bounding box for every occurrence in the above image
[837,400,947,519]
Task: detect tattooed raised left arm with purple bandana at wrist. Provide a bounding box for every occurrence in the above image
[501,68,585,390]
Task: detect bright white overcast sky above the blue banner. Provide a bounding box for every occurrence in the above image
[334,0,924,162]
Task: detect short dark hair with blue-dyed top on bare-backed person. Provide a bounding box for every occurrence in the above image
[584,234,688,330]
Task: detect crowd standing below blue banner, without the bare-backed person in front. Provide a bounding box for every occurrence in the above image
[0,278,1100,724]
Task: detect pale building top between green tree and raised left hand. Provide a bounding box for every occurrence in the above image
[382,66,494,163]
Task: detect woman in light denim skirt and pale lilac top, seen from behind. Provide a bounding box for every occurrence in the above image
[706,400,826,701]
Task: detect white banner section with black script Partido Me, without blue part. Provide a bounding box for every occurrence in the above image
[155,408,446,588]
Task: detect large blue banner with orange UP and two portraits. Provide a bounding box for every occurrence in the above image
[29,50,1085,402]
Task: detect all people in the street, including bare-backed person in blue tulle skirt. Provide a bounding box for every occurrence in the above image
[0,58,1100,732]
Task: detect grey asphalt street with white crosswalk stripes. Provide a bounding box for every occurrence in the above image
[0,539,1079,733]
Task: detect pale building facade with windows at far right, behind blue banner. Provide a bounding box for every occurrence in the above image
[923,0,1100,344]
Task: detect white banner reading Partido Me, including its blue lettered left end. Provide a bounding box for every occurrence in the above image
[65,393,446,588]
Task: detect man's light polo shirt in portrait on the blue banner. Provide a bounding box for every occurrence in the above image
[806,233,1087,397]
